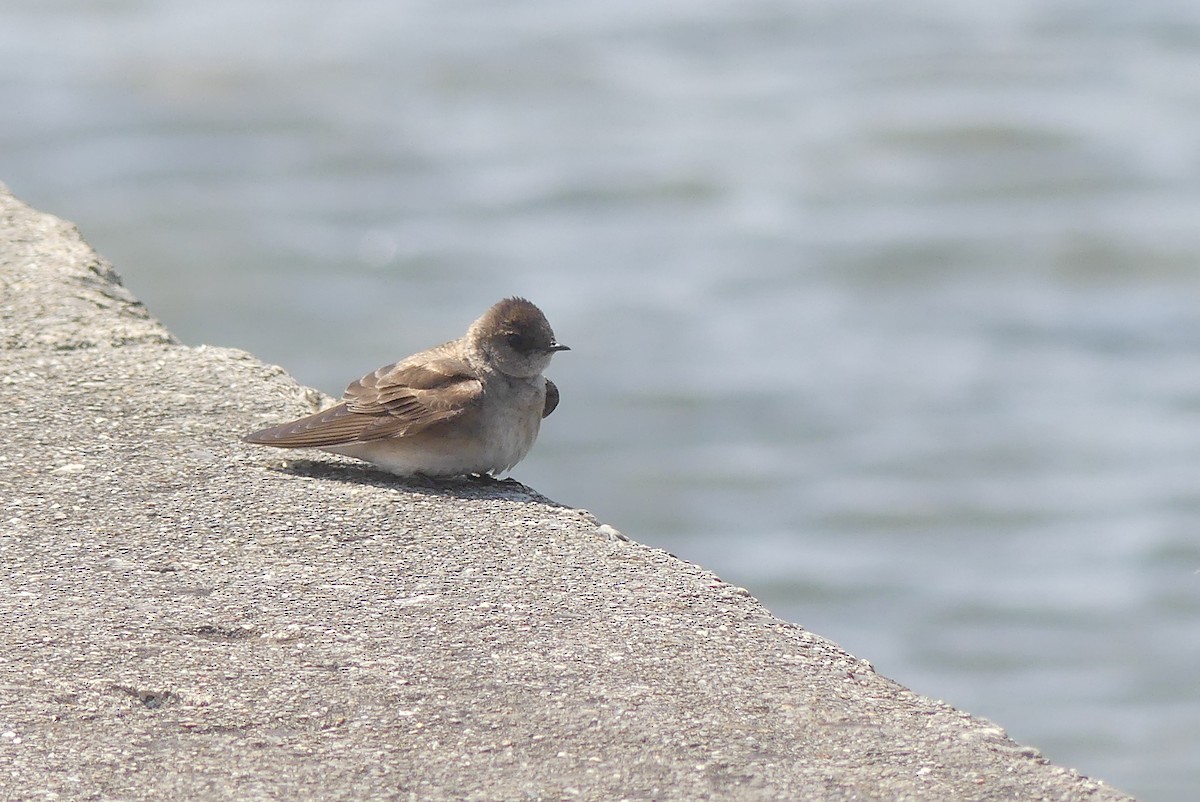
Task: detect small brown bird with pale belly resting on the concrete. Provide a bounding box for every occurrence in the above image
[242,298,570,477]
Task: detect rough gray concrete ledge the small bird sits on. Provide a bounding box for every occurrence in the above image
[0,186,1130,802]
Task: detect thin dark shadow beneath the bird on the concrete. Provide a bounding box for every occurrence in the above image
[268,460,565,507]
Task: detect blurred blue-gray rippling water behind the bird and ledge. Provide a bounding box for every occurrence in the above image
[0,0,1200,802]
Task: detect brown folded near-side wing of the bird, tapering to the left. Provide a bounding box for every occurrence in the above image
[245,358,484,448]
